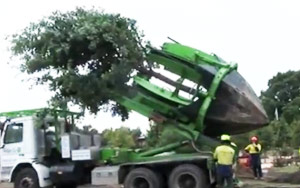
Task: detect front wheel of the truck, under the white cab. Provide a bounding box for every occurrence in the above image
[14,168,40,188]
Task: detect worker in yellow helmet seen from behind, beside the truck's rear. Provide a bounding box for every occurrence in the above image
[214,134,235,188]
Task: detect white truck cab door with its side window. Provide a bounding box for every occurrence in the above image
[0,123,23,181]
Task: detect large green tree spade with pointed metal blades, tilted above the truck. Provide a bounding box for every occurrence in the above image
[118,43,268,136]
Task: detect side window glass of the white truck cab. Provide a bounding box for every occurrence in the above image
[4,123,23,144]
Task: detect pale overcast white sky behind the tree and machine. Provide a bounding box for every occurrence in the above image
[0,0,300,130]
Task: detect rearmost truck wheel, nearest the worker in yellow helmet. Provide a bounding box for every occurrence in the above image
[169,164,208,188]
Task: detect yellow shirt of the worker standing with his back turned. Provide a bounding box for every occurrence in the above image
[214,145,235,165]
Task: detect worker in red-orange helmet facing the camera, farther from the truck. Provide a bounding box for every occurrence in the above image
[245,136,263,179]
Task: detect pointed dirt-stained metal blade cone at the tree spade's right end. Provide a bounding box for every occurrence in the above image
[198,66,268,136]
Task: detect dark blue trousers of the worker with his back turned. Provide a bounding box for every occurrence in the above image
[217,164,233,188]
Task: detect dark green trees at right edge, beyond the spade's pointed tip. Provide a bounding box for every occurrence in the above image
[260,71,300,148]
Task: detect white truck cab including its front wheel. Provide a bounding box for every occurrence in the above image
[0,117,51,188]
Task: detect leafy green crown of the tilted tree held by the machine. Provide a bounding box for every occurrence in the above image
[12,8,151,119]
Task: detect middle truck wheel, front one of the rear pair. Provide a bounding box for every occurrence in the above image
[124,168,162,188]
